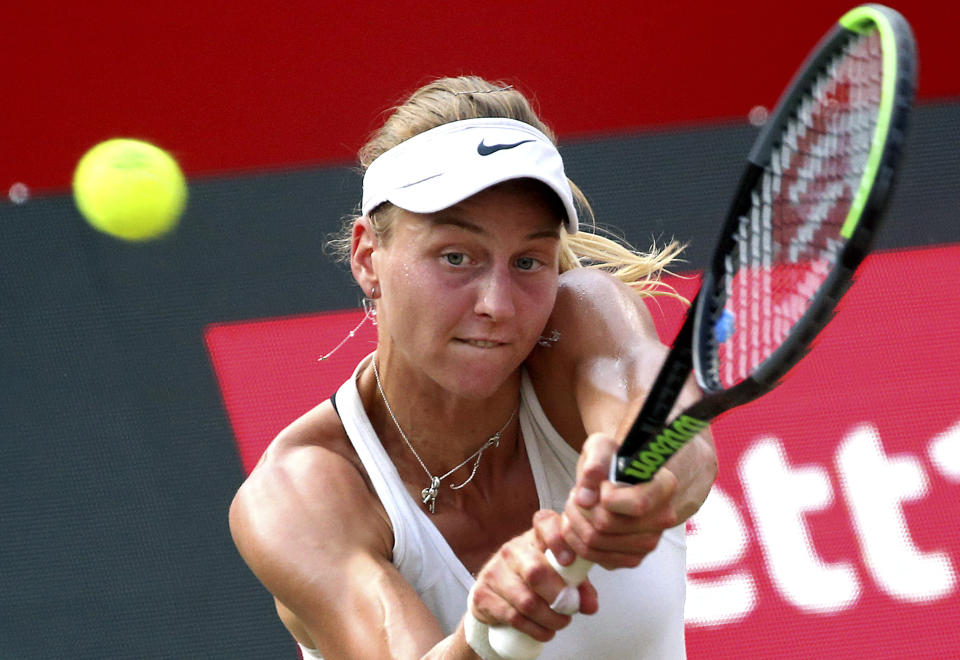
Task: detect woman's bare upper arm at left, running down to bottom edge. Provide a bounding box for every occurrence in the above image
[230,426,443,658]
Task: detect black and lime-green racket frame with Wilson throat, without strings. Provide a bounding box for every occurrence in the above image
[610,4,916,483]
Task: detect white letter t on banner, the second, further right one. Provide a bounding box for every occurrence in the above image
[837,426,956,602]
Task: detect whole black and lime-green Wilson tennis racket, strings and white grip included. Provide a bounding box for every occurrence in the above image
[489,4,917,660]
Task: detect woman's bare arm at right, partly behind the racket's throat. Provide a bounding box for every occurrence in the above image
[528,268,716,519]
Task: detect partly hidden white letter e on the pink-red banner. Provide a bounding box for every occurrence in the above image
[686,488,757,626]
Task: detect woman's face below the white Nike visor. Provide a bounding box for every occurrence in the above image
[372,182,561,398]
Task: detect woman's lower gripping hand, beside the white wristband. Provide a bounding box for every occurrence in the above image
[467,511,598,642]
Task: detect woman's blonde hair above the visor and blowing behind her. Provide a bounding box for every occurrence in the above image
[328,76,683,298]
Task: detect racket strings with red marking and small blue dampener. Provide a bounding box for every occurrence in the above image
[713,31,883,388]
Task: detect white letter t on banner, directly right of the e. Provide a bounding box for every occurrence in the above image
[740,439,860,612]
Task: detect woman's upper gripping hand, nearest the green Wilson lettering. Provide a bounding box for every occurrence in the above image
[534,433,681,569]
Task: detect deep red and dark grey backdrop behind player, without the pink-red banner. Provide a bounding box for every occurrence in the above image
[0,0,960,659]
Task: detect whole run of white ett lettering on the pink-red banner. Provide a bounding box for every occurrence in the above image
[686,422,960,626]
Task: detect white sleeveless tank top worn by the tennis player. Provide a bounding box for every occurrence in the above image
[303,359,686,660]
